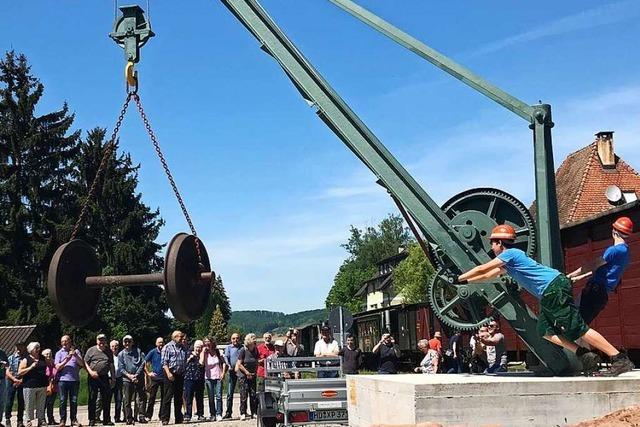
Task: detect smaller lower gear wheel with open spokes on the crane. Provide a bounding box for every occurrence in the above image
[428,268,496,331]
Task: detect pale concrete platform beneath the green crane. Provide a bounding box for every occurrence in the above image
[347,370,640,427]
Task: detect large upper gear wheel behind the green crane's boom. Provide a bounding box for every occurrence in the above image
[429,188,537,268]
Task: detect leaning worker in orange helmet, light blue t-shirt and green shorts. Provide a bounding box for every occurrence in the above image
[457,224,634,376]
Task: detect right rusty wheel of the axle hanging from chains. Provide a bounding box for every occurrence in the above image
[164,233,215,322]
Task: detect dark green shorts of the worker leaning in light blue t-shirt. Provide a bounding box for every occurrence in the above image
[538,274,589,341]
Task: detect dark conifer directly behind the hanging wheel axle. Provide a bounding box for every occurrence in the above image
[74,128,170,347]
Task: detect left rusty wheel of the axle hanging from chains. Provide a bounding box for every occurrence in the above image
[47,239,100,326]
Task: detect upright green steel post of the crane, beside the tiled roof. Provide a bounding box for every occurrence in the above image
[530,104,564,271]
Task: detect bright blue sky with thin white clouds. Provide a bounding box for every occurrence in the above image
[0,0,640,312]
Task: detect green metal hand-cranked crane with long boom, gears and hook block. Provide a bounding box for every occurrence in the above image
[112,0,580,375]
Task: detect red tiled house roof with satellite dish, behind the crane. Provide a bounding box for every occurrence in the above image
[556,142,640,225]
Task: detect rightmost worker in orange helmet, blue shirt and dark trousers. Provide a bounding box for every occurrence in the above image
[567,216,633,324]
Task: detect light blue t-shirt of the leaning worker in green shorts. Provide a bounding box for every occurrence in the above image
[498,248,560,299]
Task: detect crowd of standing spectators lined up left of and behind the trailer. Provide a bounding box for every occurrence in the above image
[0,329,303,427]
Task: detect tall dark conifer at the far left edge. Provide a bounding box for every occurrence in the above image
[0,51,79,337]
